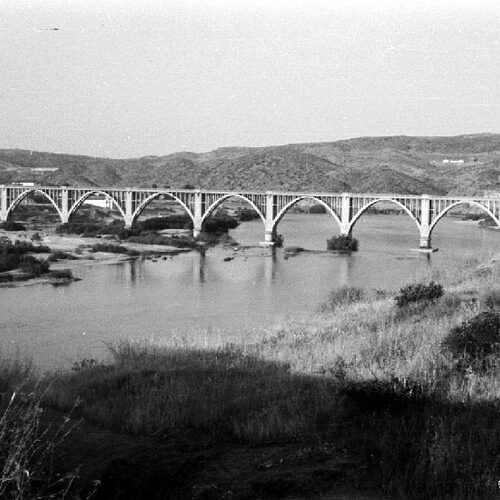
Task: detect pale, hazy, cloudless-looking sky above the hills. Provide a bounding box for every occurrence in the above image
[0,0,500,157]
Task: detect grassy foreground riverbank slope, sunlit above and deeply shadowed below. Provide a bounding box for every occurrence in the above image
[1,256,500,499]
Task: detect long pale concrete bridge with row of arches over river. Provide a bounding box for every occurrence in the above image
[0,185,500,249]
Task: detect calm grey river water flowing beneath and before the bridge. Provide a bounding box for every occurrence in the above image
[0,214,500,368]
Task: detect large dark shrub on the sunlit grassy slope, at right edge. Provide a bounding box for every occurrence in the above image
[442,311,500,358]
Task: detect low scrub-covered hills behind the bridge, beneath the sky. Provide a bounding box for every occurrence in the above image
[0,133,500,195]
